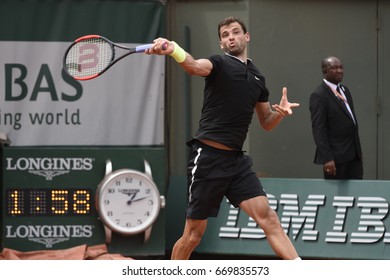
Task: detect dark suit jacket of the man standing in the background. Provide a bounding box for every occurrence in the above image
[310,82,362,164]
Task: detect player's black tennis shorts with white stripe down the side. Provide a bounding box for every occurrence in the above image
[186,140,266,220]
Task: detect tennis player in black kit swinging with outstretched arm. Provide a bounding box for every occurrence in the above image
[146,17,300,260]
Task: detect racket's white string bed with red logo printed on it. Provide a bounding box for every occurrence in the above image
[65,38,115,79]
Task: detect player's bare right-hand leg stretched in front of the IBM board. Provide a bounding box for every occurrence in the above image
[239,196,299,260]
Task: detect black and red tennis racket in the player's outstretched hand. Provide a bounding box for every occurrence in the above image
[63,35,165,80]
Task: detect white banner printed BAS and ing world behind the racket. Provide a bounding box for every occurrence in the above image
[0,41,165,146]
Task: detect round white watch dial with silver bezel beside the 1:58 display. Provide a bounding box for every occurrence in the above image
[96,169,160,234]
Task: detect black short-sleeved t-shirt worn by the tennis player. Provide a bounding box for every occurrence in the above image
[194,54,269,150]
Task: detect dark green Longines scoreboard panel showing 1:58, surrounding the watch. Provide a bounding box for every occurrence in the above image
[0,147,166,256]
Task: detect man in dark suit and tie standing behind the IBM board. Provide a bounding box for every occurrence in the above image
[310,56,363,179]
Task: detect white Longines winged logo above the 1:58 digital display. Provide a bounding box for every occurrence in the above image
[6,157,94,181]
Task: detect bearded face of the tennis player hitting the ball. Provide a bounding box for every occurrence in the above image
[219,22,249,56]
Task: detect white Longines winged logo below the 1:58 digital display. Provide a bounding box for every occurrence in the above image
[6,225,93,248]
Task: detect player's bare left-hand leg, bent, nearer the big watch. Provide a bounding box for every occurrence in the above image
[171,219,207,260]
